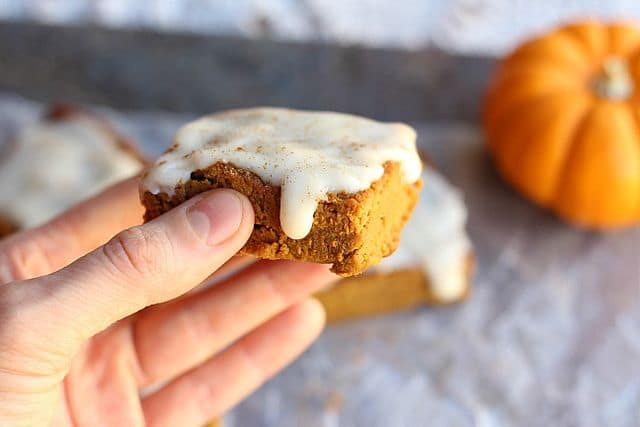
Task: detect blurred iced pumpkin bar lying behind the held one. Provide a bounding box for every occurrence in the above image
[316,166,474,322]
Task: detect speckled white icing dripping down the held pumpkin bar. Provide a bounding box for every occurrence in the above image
[141,108,422,239]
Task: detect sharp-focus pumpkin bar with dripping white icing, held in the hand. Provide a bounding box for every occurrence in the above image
[141,108,422,276]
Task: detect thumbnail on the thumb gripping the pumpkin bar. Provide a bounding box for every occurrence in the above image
[187,190,242,246]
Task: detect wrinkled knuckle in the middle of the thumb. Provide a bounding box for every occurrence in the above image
[103,228,171,278]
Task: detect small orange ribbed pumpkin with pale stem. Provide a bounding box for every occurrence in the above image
[484,22,640,228]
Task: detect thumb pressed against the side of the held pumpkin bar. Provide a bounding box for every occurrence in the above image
[2,190,254,360]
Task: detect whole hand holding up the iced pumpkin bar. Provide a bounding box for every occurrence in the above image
[0,180,334,427]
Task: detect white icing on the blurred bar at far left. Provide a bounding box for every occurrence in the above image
[0,116,142,227]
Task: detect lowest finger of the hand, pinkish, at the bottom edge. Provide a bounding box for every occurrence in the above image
[142,299,324,427]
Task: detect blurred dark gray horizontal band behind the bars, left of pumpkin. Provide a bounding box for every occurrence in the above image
[0,22,493,120]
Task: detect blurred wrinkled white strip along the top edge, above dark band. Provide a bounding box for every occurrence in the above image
[0,0,640,55]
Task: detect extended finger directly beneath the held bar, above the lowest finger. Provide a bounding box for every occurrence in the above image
[133,261,337,387]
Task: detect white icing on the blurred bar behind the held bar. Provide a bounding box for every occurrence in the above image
[371,167,472,302]
